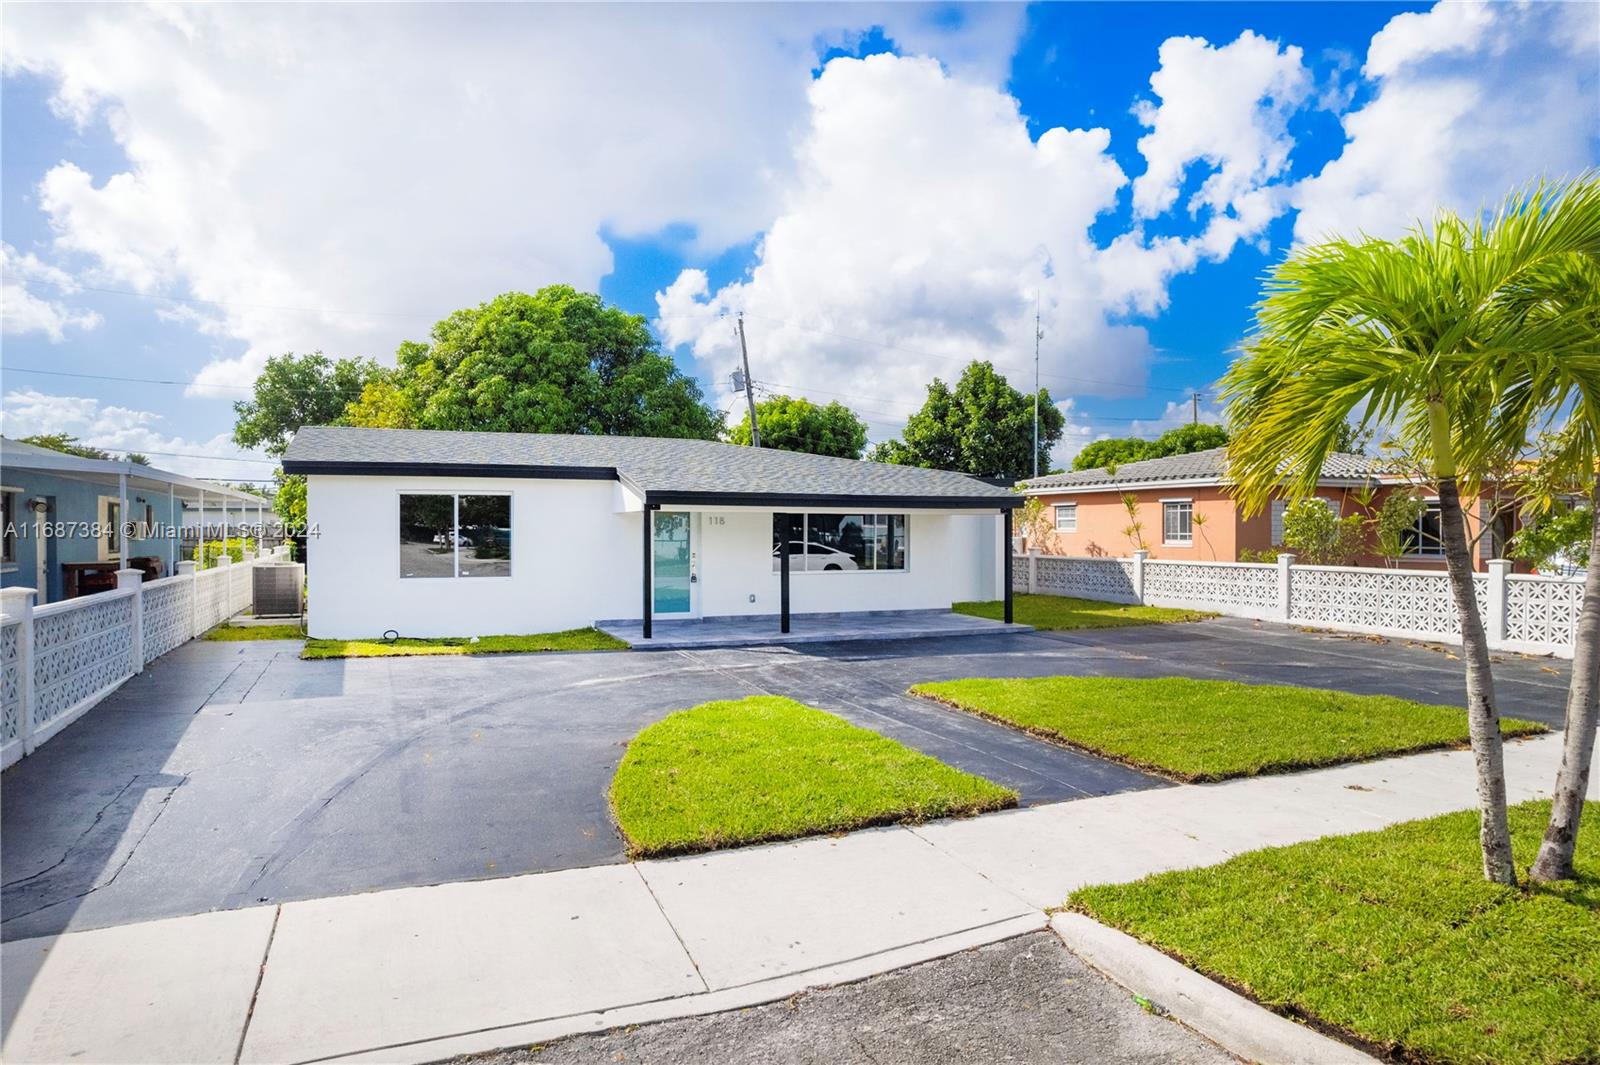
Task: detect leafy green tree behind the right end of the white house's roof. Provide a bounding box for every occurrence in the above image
[869,363,1066,481]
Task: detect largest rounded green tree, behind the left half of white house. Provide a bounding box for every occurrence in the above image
[356,285,722,440]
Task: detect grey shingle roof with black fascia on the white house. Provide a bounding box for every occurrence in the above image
[283,425,1021,507]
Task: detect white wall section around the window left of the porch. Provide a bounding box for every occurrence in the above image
[306,475,640,640]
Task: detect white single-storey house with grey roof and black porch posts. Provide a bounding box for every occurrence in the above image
[283,427,1021,640]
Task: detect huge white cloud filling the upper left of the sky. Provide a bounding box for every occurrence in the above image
[3,5,1022,392]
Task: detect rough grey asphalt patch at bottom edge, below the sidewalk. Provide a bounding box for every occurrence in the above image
[453,932,1237,1065]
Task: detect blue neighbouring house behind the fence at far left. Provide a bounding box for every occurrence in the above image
[0,438,277,603]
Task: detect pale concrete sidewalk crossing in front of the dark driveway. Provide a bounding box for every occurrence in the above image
[0,736,1600,1063]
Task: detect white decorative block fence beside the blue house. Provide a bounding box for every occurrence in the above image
[0,547,288,768]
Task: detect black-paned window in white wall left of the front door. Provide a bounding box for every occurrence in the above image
[400,494,510,577]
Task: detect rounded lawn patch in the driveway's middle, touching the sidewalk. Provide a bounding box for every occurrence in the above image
[611,696,1018,857]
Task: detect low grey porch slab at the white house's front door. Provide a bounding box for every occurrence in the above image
[595,611,1034,651]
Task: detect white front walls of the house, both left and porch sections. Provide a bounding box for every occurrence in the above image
[306,475,1003,640]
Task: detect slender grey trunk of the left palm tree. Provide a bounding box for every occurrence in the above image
[1438,475,1517,884]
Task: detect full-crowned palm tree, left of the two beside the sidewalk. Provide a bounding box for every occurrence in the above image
[1224,182,1597,884]
